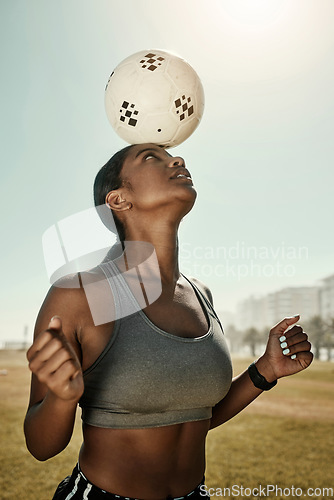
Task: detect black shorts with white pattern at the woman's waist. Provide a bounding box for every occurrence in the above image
[52,464,210,500]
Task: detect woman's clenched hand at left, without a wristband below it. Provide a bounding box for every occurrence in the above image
[27,316,84,401]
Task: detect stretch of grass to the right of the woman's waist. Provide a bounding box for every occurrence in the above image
[206,359,334,500]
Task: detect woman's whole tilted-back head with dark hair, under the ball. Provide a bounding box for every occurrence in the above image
[94,143,196,241]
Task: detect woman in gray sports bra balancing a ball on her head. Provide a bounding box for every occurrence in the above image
[25,144,312,500]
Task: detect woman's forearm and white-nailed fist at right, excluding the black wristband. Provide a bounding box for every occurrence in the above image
[210,316,313,429]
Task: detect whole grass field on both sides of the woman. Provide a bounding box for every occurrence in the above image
[0,351,334,500]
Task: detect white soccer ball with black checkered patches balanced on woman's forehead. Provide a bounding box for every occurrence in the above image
[105,50,204,148]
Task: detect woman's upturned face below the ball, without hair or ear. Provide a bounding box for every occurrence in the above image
[121,143,196,212]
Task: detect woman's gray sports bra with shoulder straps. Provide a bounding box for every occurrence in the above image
[79,262,232,429]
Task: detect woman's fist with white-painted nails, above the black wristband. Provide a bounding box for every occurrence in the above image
[256,316,313,382]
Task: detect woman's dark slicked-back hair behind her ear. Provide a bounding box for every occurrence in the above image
[94,145,133,241]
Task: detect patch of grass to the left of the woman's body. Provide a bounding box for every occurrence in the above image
[0,351,81,500]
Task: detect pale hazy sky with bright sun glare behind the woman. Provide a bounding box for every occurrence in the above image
[0,0,334,340]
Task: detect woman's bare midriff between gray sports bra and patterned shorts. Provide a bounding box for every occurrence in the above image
[79,420,210,500]
